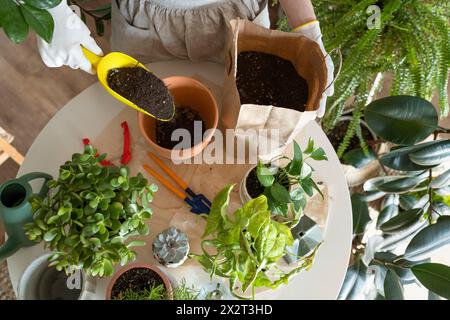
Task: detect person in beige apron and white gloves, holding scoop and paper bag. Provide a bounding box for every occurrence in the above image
[38,0,333,116]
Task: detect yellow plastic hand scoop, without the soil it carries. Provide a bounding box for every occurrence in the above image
[82,47,175,121]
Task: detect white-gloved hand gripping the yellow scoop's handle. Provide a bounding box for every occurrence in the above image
[37,0,103,74]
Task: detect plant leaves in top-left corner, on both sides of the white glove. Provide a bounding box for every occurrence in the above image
[0,0,111,43]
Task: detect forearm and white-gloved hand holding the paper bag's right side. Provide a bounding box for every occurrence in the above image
[280,0,334,117]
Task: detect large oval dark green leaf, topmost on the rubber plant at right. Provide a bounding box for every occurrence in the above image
[364,96,438,145]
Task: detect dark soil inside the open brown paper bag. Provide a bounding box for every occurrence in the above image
[236,51,308,111]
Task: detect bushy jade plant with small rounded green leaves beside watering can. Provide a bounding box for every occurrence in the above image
[25,145,157,276]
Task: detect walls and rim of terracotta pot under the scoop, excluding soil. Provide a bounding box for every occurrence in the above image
[138,76,219,161]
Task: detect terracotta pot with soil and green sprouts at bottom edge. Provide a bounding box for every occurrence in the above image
[106,263,173,300]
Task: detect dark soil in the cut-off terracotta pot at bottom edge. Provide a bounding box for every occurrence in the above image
[111,268,164,300]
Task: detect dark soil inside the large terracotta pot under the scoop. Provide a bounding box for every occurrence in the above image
[156,106,206,149]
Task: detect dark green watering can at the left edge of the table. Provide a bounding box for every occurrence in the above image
[0,172,52,261]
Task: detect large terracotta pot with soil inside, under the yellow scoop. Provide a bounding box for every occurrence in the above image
[138,76,219,160]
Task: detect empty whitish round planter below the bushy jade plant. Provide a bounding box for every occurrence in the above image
[17,254,96,300]
